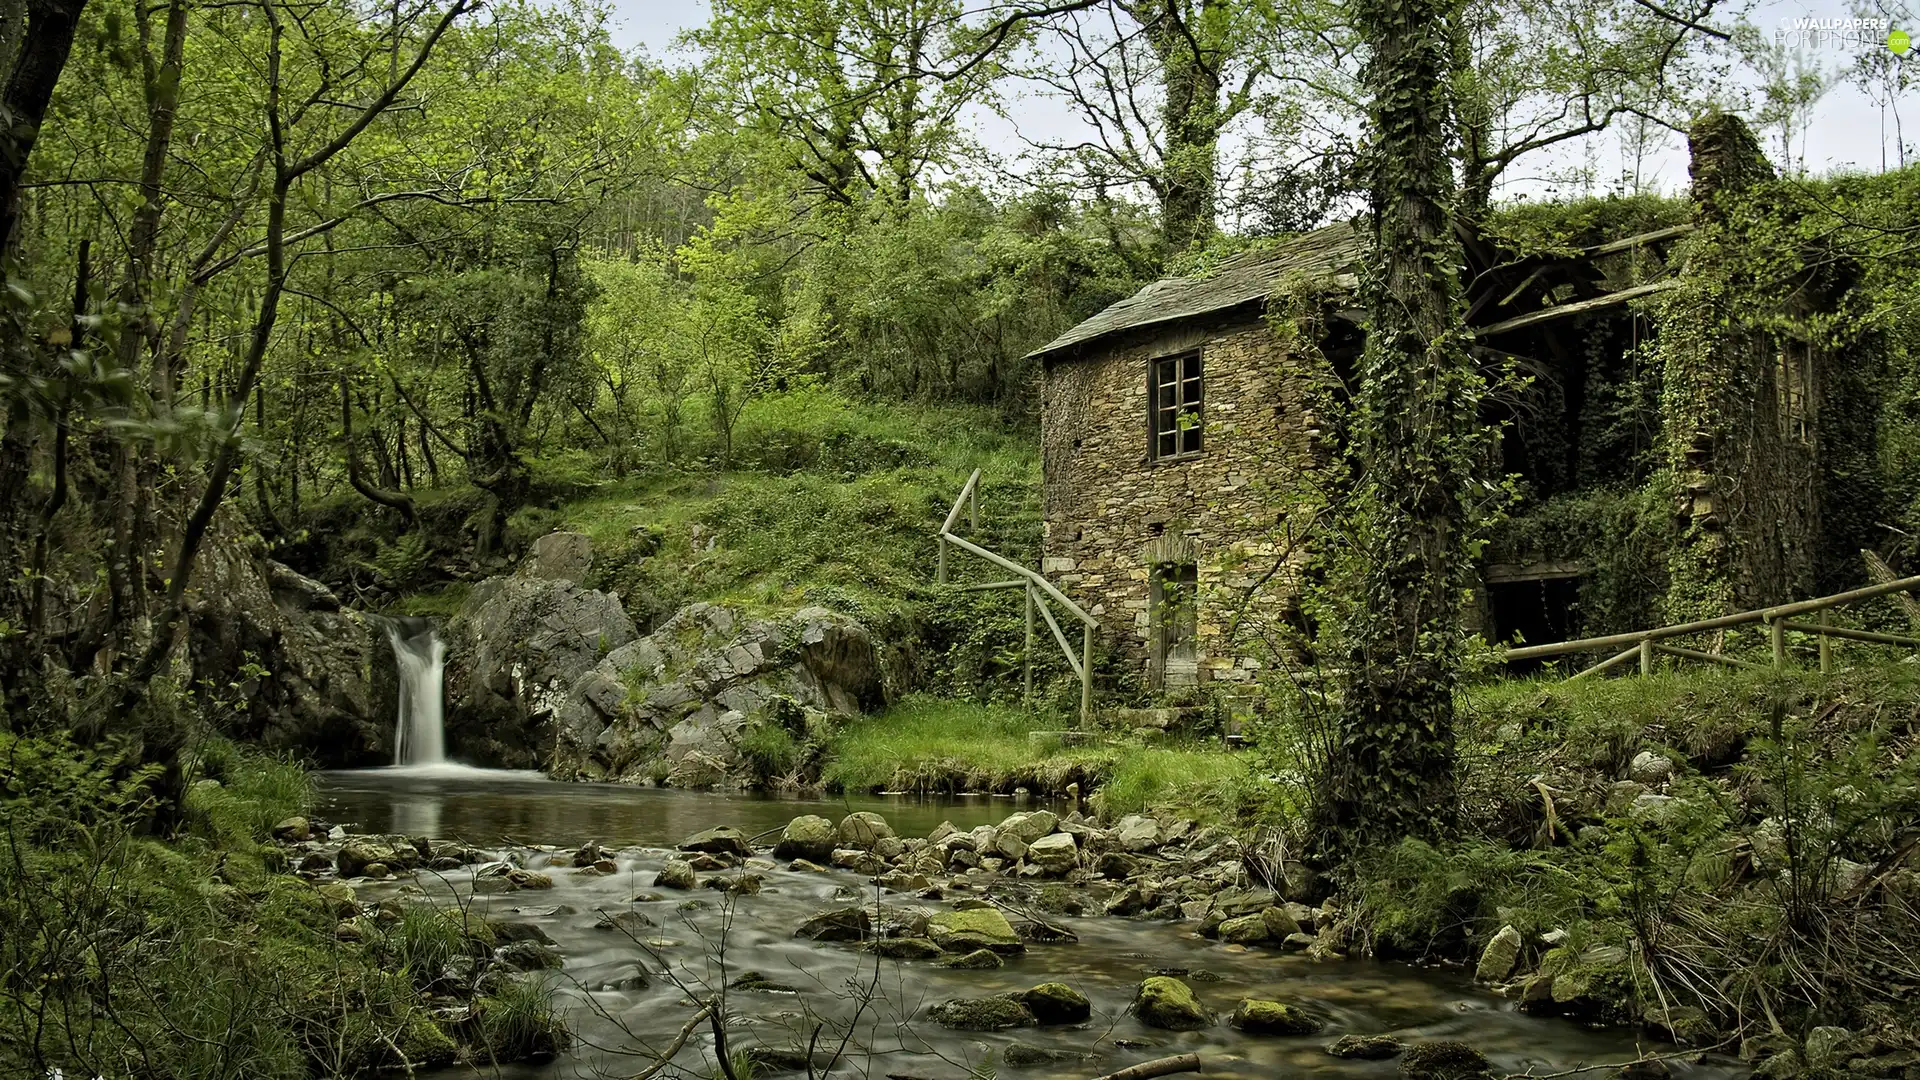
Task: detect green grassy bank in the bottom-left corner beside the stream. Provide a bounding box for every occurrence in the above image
[0,734,553,1080]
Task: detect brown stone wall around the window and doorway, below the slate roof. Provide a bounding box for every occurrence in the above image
[1041,311,1321,682]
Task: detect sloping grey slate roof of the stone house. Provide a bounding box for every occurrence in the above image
[1027,221,1367,357]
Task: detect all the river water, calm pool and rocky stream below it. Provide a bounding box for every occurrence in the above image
[319,767,1745,1080]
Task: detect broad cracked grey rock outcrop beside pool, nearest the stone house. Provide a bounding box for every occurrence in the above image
[553,603,887,788]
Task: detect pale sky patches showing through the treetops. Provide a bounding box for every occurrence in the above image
[611,0,1920,198]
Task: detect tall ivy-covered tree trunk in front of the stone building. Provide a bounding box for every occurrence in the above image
[1319,0,1484,857]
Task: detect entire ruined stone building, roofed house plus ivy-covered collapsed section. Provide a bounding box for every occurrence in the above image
[1033,117,1860,688]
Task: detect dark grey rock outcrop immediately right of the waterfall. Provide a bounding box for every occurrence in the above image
[447,532,639,769]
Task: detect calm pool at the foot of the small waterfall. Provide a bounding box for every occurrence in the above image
[319,765,1036,846]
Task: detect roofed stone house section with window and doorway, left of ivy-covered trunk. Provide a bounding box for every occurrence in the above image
[1033,223,1363,688]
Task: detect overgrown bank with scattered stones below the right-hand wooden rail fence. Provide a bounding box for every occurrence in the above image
[1348,663,1920,1076]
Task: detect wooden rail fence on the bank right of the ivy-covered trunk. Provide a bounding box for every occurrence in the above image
[1503,577,1920,678]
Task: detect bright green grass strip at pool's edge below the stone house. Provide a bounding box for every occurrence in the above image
[822,696,1250,817]
